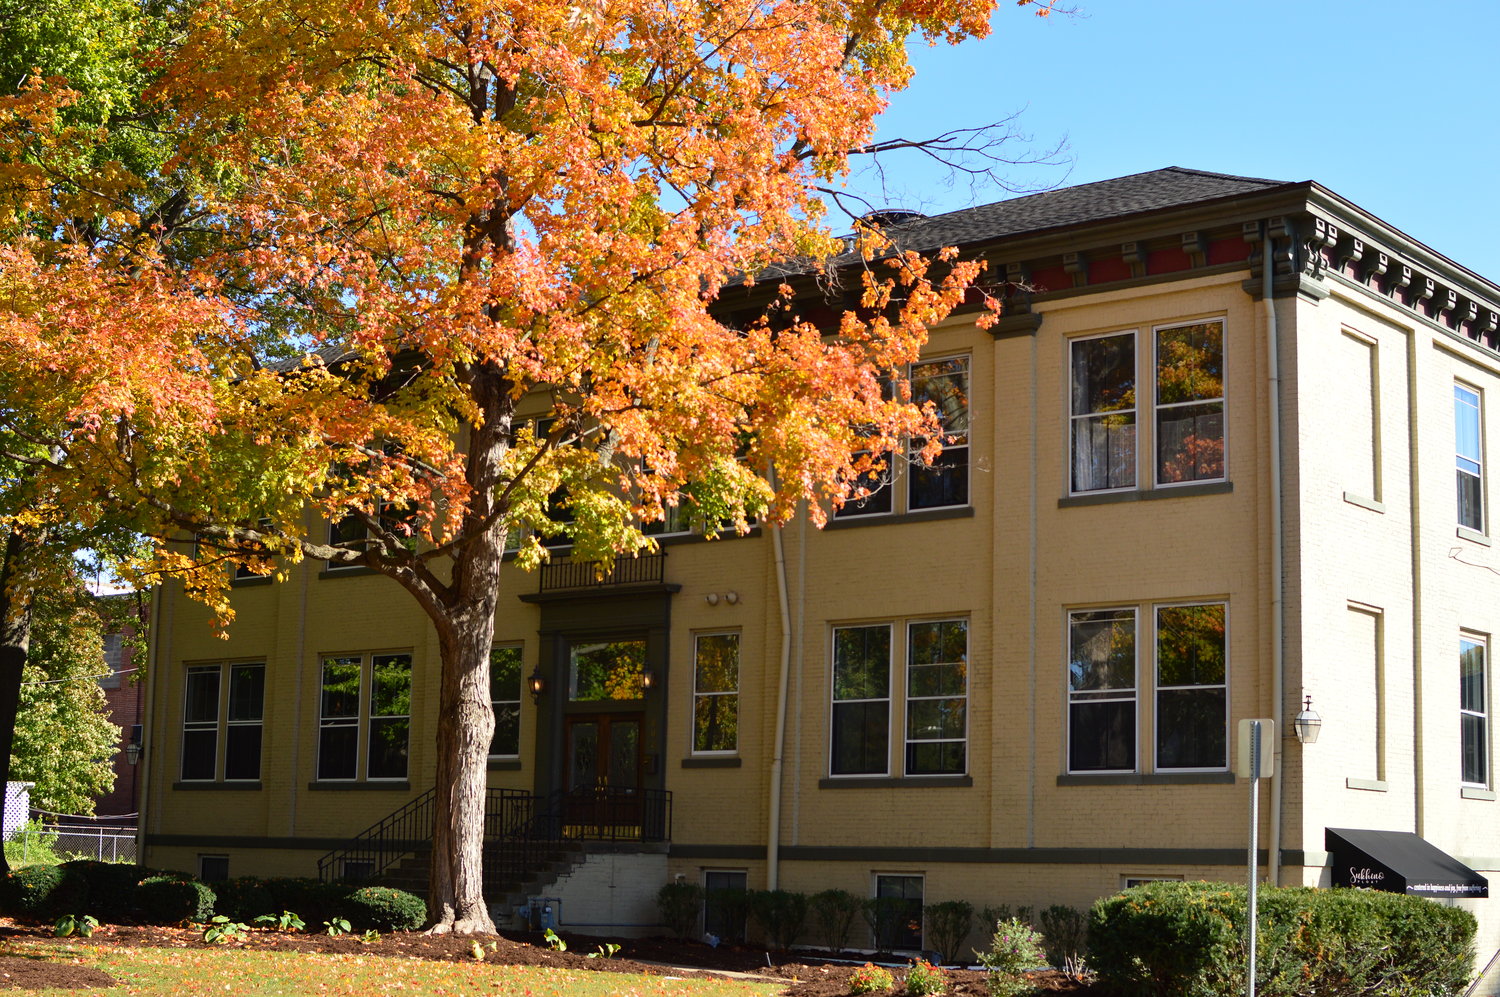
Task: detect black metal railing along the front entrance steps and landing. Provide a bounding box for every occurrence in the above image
[318,787,672,886]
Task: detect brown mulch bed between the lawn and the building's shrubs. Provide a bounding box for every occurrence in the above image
[0,919,1107,997]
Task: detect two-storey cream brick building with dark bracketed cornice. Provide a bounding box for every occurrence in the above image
[143,168,1500,963]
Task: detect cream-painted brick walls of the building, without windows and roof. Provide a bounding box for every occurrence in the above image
[147,257,1500,977]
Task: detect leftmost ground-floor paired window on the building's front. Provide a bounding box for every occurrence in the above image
[180,661,266,783]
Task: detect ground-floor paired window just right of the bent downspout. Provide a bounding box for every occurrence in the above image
[828,619,969,777]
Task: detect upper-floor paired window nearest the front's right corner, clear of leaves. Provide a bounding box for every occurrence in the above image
[1068,319,1224,493]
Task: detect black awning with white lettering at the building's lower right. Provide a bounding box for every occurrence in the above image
[1323,828,1490,897]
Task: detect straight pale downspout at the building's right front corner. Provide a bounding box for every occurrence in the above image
[1260,227,1286,886]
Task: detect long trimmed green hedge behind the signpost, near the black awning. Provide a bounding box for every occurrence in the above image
[1089,883,1476,997]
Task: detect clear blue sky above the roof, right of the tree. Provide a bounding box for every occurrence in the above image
[858,0,1500,280]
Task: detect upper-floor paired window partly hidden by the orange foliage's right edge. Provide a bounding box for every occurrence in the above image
[834,355,969,519]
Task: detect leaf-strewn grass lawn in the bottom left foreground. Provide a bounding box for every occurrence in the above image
[0,942,783,997]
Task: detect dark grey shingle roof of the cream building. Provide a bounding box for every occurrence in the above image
[810,166,1289,265]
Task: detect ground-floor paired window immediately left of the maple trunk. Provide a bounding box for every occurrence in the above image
[318,654,411,781]
